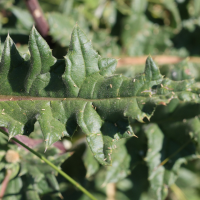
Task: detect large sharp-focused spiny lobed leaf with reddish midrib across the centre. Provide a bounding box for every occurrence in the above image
[0,25,199,165]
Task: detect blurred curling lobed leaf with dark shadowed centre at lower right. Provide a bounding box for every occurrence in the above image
[144,122,199,200]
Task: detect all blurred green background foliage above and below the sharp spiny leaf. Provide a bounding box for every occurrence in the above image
[0,0,200,200]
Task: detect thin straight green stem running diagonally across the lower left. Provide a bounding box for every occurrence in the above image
[0,129,97,200]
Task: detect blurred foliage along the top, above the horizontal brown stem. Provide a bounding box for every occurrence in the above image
[0,0,200,58]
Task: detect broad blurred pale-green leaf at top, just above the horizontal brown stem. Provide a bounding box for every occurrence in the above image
[121,0,173,56]
